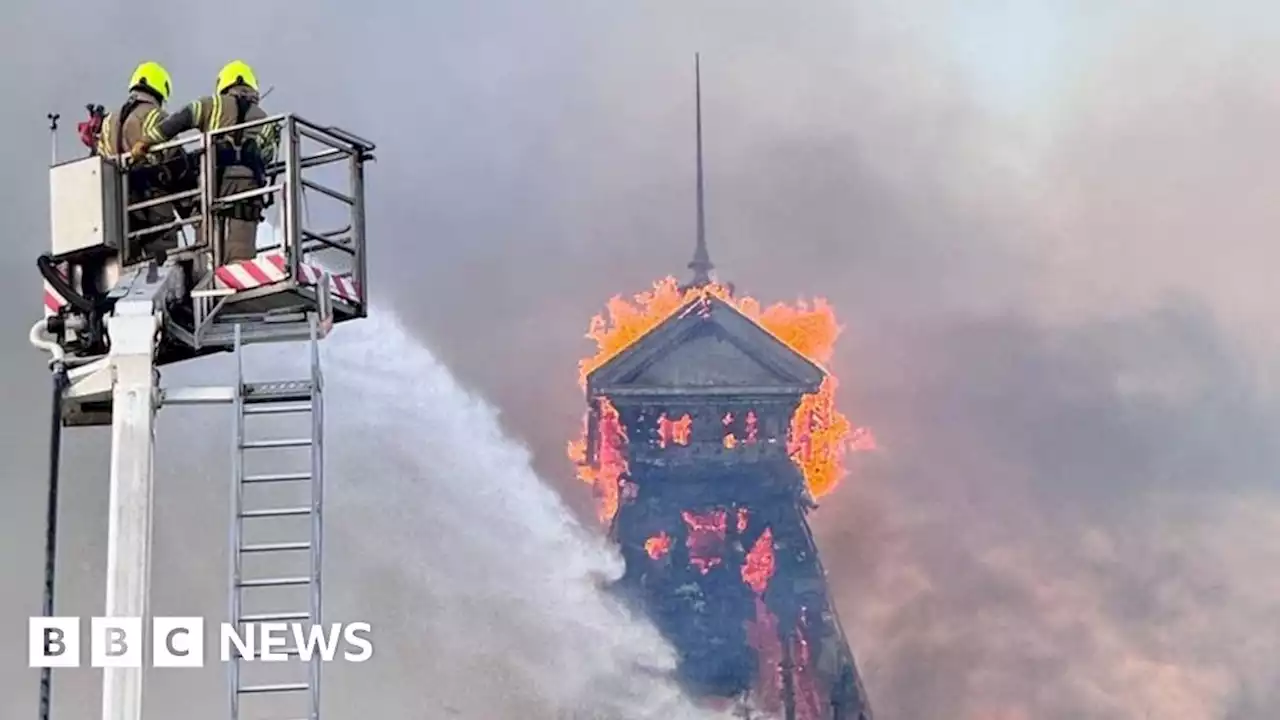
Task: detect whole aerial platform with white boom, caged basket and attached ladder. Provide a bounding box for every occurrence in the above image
[29,108,374,720]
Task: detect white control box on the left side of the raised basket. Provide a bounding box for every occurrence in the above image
[49,155,124,258]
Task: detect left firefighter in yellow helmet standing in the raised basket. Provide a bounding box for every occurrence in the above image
[97,61,186,257]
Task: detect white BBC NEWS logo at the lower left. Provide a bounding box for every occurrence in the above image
[27,618,374,667]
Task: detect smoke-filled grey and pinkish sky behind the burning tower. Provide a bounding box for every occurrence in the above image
[0,0,1280,720]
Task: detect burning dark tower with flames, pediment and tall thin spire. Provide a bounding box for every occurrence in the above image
[570,57,870,720]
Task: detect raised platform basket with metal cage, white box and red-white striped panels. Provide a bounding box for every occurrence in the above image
[41,114,374,365]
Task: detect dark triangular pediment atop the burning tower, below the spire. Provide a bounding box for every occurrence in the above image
[588,297,824,396]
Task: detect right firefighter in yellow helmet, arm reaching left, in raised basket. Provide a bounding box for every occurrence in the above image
[131,60,279,263]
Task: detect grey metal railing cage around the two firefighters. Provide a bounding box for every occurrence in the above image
[120,114,375,329]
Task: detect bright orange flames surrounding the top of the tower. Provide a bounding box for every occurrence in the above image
[570,277,876,521]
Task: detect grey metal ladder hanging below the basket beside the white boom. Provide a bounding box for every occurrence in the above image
[229,315,324,720]
